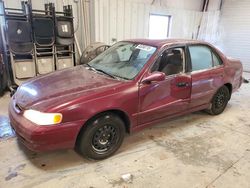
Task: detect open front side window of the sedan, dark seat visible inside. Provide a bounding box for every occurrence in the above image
[151,47,185,75]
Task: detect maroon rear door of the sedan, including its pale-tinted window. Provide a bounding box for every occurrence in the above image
[188,45,224,108]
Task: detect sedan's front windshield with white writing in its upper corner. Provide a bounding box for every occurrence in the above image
[88,42,156,80]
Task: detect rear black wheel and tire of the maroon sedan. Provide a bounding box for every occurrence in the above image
[208,86,230,115]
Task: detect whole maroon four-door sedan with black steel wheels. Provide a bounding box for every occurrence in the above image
[9,40,242,159]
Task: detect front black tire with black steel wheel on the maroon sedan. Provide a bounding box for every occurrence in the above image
[76,113,125,160]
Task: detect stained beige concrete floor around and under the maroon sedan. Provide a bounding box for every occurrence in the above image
[0,74,250,188]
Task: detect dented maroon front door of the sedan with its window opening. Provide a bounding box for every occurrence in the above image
[139,47,192,125]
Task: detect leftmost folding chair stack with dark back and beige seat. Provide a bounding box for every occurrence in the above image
[6,2,36,85]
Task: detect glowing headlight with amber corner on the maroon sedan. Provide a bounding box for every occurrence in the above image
[23,110,62,125]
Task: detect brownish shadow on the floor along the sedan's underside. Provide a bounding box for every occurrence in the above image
[12,108,217,171]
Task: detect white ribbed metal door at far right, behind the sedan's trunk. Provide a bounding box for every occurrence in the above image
[220,0,250,71]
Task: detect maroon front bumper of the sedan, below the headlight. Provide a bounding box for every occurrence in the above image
[9,100,85,151]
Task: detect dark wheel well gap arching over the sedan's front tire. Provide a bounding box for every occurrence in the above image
[76,110,130,144]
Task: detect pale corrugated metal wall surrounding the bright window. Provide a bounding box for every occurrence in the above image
[94,0,219,44]
